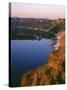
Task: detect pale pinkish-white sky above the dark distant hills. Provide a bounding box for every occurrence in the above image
[11,2,65,19]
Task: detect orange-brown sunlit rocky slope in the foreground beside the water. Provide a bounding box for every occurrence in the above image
[20,32,65,86]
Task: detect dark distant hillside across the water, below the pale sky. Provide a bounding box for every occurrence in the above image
[9,18,65,40]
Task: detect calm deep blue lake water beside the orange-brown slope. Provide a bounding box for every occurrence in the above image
[11,39,53,87]
